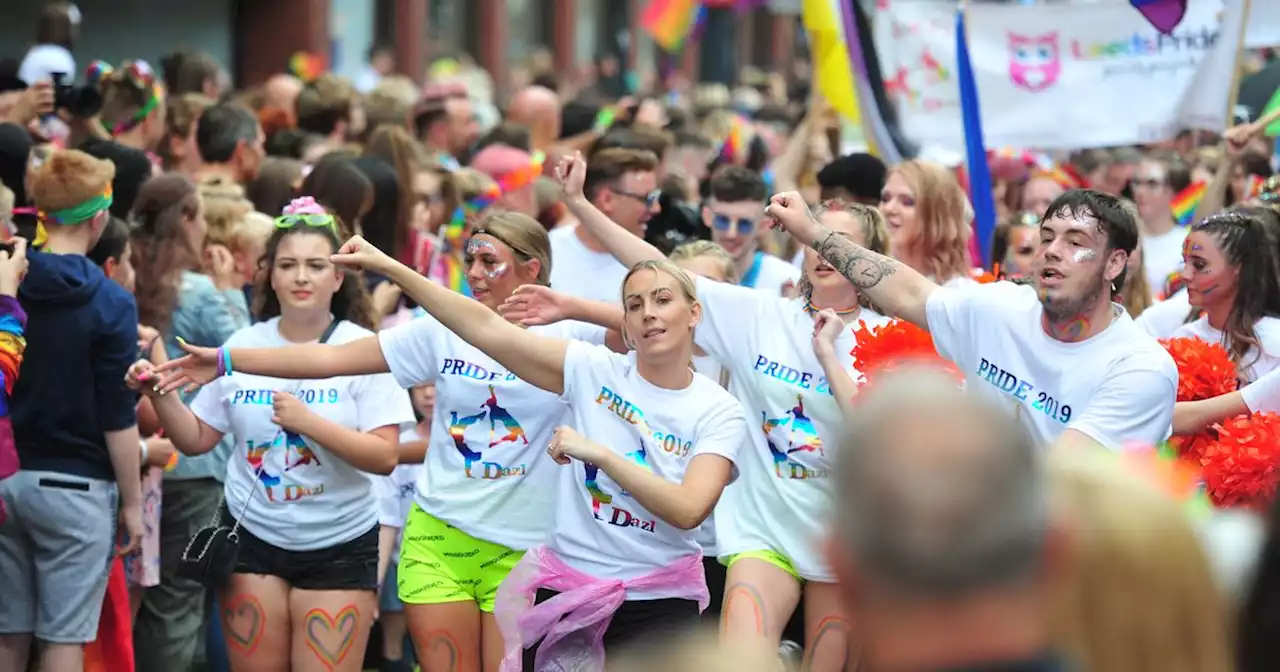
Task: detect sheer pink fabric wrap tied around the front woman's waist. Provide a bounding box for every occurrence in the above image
[494,547,710,672]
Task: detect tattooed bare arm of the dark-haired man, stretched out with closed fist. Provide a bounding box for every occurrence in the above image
[765,192,938,329]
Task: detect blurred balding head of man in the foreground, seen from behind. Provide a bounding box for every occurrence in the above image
[836,366,1050,600]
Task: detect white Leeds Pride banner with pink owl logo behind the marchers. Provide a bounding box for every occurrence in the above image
[874,0,1243,152]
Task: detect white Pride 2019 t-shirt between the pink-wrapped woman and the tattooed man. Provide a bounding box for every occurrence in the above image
[695,278,888,582]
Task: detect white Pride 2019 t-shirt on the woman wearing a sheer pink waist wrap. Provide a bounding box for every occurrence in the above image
[550,343,748,599]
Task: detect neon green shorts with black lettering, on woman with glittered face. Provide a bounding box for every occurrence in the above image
[396,504,525,613]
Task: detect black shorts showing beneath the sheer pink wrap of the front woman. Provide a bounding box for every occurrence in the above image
[522,588,700,672]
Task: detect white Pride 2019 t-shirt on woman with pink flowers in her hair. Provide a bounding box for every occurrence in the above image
[191,317,413,550]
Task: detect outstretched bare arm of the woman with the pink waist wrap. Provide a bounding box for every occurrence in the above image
[333,236,568,394]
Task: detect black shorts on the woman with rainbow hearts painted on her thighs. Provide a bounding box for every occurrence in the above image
[223,507,378,590]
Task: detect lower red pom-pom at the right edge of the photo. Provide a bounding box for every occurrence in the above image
[1199,413,1280,511]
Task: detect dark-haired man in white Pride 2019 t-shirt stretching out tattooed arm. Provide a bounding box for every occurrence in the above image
[765,189,1178,451]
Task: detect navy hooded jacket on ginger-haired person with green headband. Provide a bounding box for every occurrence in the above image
[10,250,138,481]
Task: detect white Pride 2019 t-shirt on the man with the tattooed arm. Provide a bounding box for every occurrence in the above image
[927,282,1178,451]
